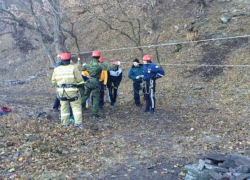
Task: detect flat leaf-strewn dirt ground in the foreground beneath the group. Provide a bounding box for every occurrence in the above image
[0,69,250,180]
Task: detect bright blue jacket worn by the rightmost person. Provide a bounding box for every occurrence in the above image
[143,63,165,81]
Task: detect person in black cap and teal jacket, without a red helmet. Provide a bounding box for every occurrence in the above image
[128,58,143,107]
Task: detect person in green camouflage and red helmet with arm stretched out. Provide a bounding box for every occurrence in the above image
[82,51,120,118]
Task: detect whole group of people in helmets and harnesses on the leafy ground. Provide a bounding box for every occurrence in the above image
[52,51,164,128]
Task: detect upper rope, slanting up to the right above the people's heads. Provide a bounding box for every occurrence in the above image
[72,35,250,55]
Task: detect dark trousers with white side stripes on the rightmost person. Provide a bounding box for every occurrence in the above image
[144,79,156,110]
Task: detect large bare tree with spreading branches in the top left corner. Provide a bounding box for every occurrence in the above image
[0,0,79,65]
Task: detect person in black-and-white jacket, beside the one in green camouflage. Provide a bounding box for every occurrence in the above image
[107,63,122,109]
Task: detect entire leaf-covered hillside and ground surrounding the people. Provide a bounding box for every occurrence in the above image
[0,0,250,180]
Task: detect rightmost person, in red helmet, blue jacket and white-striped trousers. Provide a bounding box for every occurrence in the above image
[142,54,165,114]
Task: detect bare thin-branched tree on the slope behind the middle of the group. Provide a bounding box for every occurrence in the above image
[98,0,164,62]
